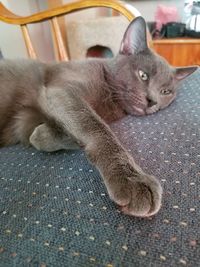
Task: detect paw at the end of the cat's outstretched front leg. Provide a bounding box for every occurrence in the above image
[108,174,162,217]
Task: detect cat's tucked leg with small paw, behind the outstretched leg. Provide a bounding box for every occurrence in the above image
[29,123,80,152]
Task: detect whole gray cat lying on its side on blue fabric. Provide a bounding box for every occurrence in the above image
[0,17,196,217]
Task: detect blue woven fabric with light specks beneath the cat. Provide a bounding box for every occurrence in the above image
[0,70,200,267]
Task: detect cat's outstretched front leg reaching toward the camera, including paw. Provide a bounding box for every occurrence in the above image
[40,88,162,217]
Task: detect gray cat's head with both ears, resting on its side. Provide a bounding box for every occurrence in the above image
[117,17,197,115]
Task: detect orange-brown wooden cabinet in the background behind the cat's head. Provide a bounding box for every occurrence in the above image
[153,38,200,66]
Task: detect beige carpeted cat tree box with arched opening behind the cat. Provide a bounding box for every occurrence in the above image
[67,16,129,59]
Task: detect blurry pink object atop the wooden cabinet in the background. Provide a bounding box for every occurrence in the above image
[155,5,179,31]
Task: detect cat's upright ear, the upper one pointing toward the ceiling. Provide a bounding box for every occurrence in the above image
[119,16,148,55]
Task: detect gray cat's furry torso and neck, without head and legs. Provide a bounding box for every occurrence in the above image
[0,59,125,145]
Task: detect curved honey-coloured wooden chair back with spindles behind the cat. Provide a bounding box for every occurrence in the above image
[0,0,139,60]
